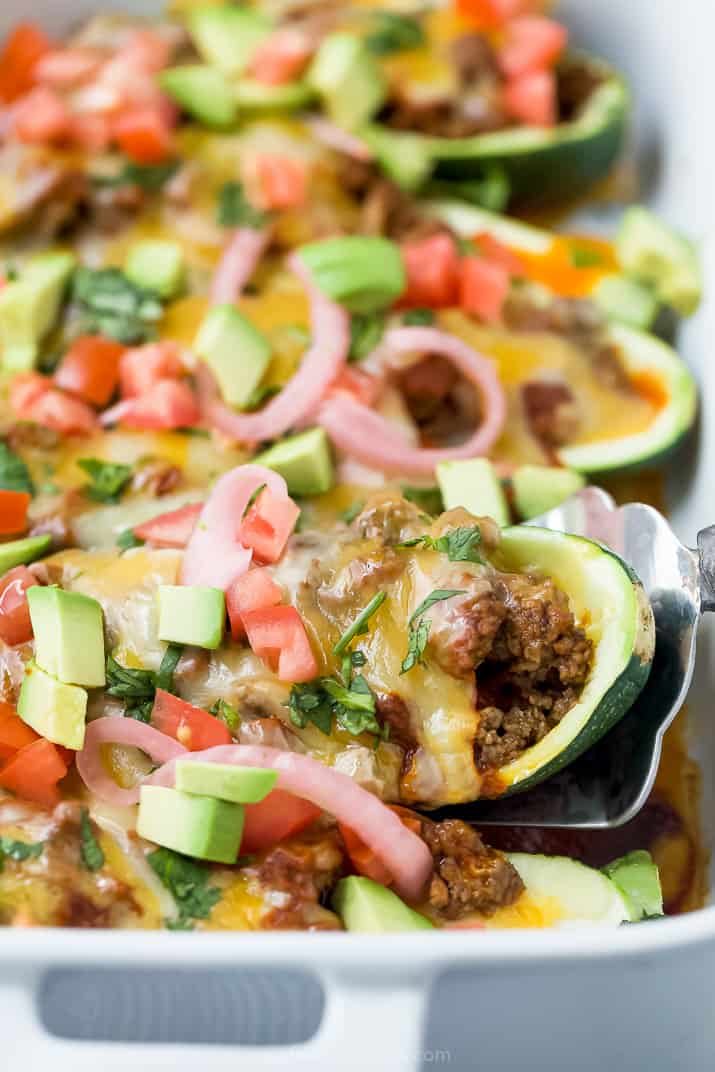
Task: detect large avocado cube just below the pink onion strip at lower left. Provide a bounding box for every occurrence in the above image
[136,786,243,864]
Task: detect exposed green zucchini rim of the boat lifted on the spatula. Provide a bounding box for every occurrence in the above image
[485,525,655,796]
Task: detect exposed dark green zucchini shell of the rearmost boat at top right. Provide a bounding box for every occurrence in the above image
[411,56,630,203]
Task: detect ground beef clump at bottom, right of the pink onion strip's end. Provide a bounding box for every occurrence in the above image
[422,819,524,920]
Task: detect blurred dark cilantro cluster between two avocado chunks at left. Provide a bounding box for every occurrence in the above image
[72,268,164,345]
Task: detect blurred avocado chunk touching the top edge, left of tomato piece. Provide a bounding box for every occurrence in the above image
[187,3,273,76]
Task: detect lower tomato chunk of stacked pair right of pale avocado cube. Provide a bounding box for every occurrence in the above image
[242,607,317,682]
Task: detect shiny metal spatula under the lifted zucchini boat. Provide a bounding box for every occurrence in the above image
[445,488,715,829]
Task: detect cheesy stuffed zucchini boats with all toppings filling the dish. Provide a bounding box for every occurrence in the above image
[0,0,700,932]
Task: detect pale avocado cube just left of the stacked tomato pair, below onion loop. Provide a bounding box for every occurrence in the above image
[159,584,226,650]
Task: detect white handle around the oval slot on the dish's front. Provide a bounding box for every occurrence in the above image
[0,967,431,1072]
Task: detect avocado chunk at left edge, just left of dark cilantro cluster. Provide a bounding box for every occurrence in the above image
[0,253,77,372]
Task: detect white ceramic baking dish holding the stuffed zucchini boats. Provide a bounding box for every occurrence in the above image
[0,0,715,1072]
